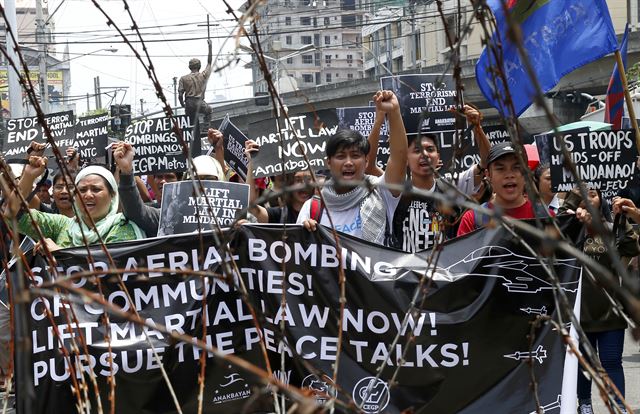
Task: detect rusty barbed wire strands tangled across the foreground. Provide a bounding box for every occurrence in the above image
[0,1,640,412]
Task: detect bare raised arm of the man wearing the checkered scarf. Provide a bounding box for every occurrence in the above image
[373,91,408,197]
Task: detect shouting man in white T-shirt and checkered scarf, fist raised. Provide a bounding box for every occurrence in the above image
[298,91,407,244]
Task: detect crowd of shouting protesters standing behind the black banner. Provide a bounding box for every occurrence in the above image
[0,89,640,413]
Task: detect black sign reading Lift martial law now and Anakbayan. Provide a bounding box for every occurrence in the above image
[249,110,338,178]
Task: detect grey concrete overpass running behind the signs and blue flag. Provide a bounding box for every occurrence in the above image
[213,32,640,132]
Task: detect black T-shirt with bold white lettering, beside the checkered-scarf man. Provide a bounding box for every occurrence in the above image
[389,184,460,252]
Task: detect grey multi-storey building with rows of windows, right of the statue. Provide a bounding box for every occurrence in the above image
[244,0,366,94]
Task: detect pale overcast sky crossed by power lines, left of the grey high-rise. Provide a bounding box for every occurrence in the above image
[49,0,251,115]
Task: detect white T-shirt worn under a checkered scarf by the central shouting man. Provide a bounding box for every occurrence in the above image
[296,175,400,238]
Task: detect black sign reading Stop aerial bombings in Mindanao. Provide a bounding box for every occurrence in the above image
[124,115,200,175]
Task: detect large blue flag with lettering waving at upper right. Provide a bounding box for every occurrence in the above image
[476,0,618,117]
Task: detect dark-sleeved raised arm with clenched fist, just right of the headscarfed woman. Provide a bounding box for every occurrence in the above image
[113,142,160,236]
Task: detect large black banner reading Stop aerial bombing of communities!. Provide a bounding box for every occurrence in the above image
[18,225,580,414]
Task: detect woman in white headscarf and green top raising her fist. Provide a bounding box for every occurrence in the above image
[7,156,145,250]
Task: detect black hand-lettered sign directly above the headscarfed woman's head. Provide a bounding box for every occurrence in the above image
[75,114,109,163]
